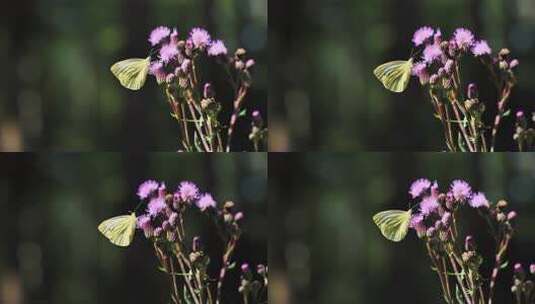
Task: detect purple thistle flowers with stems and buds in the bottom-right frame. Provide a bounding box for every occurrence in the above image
[409,179,535,304]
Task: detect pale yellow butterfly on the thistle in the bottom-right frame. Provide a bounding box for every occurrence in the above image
[373,209,412,242]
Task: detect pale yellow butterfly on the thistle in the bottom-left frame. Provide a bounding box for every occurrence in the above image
[98,212,137,247]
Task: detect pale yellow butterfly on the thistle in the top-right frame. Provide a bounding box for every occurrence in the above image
[373,58,413,93]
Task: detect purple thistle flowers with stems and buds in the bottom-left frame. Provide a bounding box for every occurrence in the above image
[137,180,268,304]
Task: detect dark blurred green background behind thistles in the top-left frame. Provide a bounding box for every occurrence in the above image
[0,0,268,151]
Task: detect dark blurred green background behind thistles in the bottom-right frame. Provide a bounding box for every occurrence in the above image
[268,153,535,304]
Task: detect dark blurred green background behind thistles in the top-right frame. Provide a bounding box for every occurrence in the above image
[268,0,535,151]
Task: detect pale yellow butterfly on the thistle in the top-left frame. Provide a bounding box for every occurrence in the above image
[110,56,150,91]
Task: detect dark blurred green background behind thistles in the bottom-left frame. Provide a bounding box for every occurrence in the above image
[0,153,267,304]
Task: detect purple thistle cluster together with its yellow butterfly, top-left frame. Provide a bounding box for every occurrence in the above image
[112,26,267,152]
